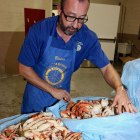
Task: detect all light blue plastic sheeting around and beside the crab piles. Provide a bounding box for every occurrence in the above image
[0,59,140,140]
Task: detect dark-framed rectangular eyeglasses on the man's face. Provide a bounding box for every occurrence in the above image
[62,11,88,24]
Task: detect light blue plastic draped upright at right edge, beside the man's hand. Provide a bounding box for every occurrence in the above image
[121,59,140,111]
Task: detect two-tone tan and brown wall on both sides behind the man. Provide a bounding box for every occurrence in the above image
[0,0,140,75]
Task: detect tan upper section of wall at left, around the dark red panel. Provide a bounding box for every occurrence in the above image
[0,0,52,31]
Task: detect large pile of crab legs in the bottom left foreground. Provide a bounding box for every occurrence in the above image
[0,112,82,140]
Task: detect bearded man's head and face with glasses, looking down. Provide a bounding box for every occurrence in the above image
[58,0,89,36]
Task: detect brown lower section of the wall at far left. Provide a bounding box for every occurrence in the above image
[0,32,24,74]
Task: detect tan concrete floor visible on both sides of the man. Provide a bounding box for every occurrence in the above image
[0,63,122,119]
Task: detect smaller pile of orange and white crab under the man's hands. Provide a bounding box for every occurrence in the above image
[60,98,117,119]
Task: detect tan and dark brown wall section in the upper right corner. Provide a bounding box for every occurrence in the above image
[119,0,140,58]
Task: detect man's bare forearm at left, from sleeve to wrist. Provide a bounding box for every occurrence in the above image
[19,64,54,93]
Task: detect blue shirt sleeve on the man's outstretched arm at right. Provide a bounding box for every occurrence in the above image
[87,39,110,68]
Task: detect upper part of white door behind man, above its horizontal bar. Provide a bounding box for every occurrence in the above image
[86,3,120,39]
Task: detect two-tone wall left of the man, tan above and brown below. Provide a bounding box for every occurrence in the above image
[0,0,52,76]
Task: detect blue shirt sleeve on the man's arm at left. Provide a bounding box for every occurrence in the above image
[18,26,40,66]
